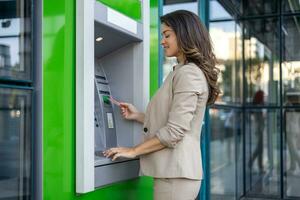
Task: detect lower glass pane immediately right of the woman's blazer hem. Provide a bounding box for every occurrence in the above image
[210,109,242,199]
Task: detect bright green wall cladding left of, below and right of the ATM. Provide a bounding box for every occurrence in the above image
[42,0,158,200]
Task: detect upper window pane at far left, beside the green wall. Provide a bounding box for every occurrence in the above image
[0,0,32,81]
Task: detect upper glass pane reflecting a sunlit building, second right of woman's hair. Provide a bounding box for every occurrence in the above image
[244,18,280,105]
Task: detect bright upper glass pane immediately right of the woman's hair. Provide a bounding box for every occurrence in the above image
[209,21,243,103]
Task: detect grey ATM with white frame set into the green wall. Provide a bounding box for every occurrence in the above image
[76,0,149,194]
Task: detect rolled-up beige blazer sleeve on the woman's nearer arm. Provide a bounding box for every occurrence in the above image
[156,66,206,148]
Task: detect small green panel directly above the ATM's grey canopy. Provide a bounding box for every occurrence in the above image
[97,0,142,21]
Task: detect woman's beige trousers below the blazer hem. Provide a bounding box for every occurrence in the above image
[154,178,201,200]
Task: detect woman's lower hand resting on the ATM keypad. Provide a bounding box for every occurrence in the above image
[103,147,137,161]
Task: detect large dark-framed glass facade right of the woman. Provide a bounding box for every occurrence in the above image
[209,0,300,199]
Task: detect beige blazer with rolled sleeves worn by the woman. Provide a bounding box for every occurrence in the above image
[140,63,208,180]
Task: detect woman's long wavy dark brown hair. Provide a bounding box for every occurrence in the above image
[160,10,220,104]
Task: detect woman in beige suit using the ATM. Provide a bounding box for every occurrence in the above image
[104,10,219,200]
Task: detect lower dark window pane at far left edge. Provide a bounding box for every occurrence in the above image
[0,88,32,199]
